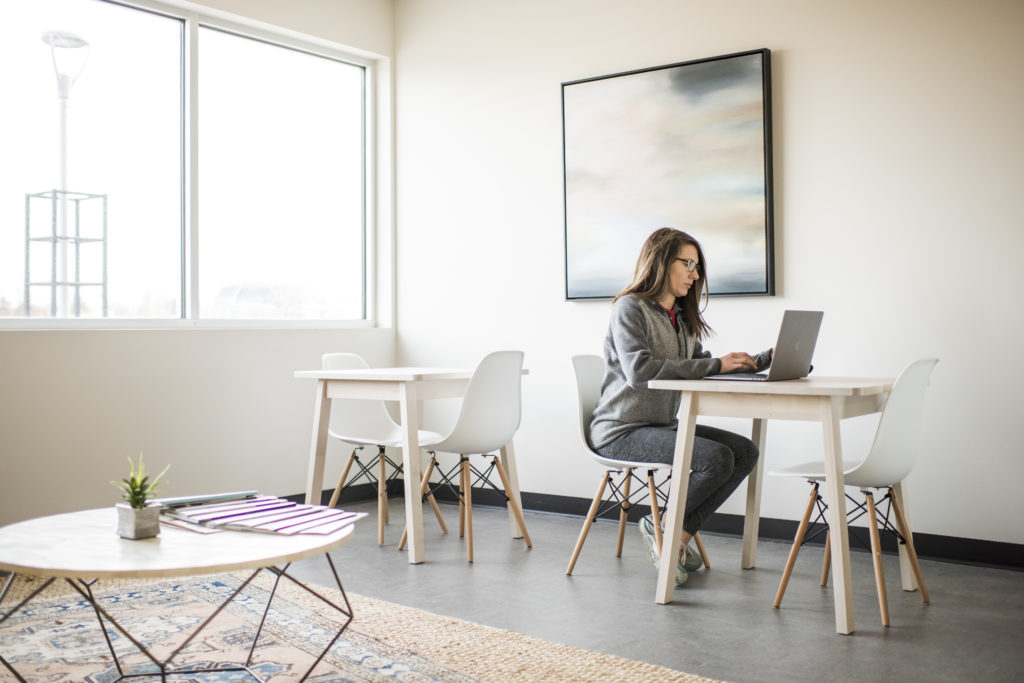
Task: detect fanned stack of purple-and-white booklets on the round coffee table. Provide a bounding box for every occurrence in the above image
[157,490,367,536]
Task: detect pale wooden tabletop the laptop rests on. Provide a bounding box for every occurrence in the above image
[647,377,893,396]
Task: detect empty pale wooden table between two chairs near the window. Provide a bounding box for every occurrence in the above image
[295,368,527,564]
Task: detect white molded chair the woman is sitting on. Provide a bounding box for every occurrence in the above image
[565,354,711,574]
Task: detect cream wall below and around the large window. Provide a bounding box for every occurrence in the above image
[0,0,395,524]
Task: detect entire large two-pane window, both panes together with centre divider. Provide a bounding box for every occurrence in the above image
[0,0,370,323]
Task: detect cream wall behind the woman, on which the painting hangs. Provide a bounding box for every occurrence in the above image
[395,0,1024,543]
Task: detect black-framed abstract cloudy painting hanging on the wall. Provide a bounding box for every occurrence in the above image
[562,49,774,299]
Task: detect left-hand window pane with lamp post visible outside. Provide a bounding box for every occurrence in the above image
[0,0,183,317]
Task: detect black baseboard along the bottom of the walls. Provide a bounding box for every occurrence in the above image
[299,479,1024,571]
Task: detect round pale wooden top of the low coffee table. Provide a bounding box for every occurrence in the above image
[0,505,354,579]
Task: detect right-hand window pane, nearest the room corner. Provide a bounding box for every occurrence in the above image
[199,29,364,318]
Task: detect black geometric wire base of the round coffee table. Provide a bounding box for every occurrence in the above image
[0,553,352,683]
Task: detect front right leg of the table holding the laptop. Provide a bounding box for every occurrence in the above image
[821,397,853,634]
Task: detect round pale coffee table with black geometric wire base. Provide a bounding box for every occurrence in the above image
[0,506,354,680]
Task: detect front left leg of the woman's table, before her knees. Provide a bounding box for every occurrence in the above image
[654,391,697,604]
